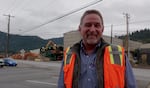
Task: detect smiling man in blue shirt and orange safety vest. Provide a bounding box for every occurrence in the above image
[58,10,136,88]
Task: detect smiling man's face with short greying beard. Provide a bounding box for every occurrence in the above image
[79,14,104,45]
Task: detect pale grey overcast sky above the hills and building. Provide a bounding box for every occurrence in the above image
[0,0,150,39]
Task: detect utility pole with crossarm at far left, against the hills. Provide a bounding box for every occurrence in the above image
[4,14,14,57]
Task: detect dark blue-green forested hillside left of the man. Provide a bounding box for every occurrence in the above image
[0,32,63,52]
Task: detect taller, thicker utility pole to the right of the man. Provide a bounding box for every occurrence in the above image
[123,13,130,58]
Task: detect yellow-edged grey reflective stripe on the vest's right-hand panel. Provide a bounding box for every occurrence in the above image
[108,45,123,66]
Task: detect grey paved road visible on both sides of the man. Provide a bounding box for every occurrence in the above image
[0,61,150,88]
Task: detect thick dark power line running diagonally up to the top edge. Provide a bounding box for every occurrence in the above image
[22,0,102,33]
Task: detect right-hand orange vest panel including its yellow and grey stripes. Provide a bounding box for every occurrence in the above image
[104,45,125,88]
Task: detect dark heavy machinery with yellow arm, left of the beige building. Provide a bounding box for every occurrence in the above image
[40,41,63,61]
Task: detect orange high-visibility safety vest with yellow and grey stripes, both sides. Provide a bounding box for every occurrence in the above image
[63,45,125,88]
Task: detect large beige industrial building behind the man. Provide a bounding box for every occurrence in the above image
[64,31,142,51]
